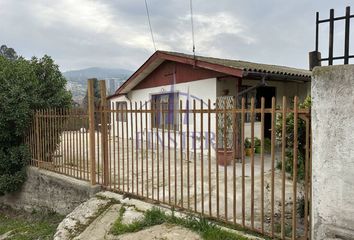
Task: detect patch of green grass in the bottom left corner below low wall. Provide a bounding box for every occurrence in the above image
[0,204,64,240]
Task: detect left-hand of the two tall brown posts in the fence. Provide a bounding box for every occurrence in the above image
[87,78,96,185]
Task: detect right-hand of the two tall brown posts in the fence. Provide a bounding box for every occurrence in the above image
[100,80,109,186]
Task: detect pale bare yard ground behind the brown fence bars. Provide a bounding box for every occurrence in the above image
[50,132,304,237]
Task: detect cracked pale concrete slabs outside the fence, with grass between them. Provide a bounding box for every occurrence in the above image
[54,192,260,240]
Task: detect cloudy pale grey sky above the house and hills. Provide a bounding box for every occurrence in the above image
[0,0,354,71]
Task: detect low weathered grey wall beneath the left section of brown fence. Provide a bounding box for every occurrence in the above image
[0,167,101,215]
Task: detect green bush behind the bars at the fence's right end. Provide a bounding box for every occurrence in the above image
[276,96,311,180]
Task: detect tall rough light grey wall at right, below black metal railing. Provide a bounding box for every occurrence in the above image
[311,65,354,240]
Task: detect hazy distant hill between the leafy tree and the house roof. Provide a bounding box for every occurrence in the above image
[63,67,133,103]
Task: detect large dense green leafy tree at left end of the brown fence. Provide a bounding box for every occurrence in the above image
[0,51,72,195]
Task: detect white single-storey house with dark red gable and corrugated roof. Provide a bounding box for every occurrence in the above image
[108,51,311,158]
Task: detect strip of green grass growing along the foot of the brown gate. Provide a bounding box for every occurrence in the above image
[111,207,247,240]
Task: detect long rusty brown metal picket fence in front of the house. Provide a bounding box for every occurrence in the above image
[26,83,311,239]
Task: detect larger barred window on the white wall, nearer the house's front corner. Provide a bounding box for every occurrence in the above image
[151,93,178,130]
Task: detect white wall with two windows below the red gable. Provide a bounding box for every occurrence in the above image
[111,78,216,156]
